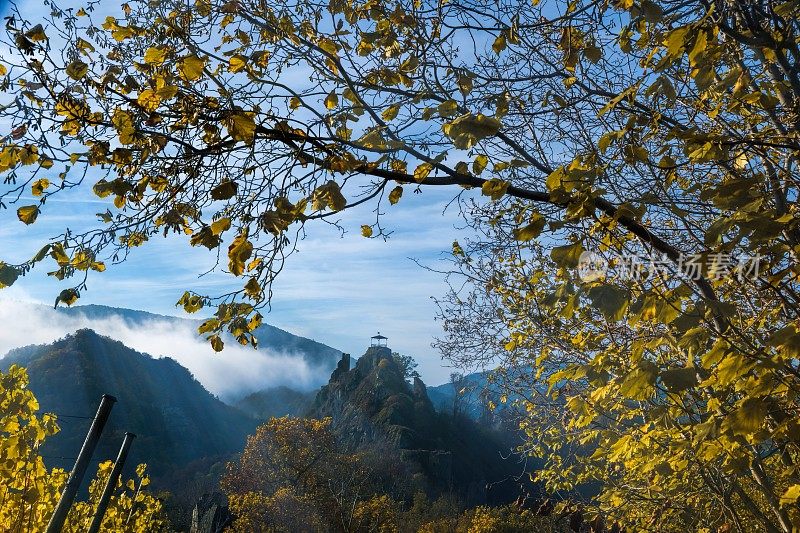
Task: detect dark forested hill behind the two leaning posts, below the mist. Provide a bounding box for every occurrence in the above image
[0,330,256,481]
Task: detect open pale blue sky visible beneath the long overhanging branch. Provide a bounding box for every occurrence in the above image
[0,0,478,384]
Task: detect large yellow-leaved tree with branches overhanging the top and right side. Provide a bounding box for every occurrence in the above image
[0,0,800,533]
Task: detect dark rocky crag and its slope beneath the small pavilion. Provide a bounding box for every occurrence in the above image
[309,346,519,504]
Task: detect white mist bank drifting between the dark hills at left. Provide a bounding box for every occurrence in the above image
[0,298,330,398]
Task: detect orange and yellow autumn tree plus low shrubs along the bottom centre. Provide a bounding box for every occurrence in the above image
[222,417,567,533]
